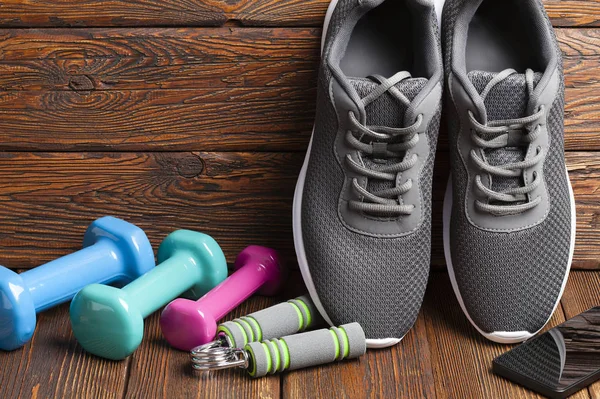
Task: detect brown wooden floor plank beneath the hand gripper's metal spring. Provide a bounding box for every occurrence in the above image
[125,297,280,399]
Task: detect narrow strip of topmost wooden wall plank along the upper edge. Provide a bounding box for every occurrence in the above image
[0,0,600,27]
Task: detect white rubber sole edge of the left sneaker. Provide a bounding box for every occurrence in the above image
[292,0,445,349]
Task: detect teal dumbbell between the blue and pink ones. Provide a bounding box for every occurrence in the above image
[71,230,227,360]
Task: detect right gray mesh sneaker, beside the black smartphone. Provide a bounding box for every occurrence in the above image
[443,0,575,343]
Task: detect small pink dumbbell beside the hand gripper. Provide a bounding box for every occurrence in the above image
[160,246,287,351]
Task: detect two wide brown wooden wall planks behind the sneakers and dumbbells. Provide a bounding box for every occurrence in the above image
[0,26,600,269]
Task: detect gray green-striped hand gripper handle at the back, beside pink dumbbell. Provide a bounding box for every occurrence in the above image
[217,295,324,348]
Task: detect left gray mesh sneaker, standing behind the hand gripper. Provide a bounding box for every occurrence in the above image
[293,0,443,347]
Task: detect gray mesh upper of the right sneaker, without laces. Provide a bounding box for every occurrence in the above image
[444,0,572,333]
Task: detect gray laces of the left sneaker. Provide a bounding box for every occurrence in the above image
[346,72,423,216]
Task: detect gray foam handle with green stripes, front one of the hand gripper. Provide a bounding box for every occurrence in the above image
[245,323,367,377]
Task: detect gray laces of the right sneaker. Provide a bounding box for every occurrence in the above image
[469,69,545,216]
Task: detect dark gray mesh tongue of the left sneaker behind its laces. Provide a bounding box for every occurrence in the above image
[349,78,428,212]
